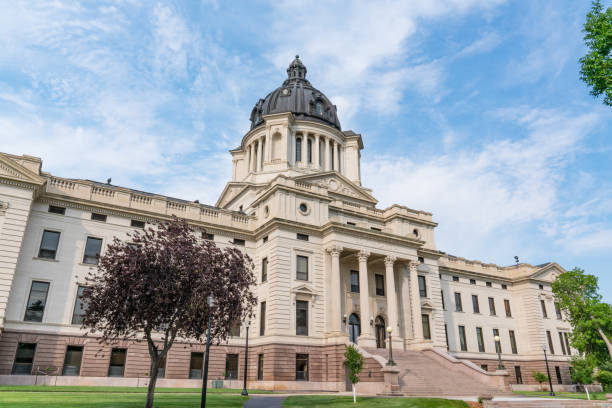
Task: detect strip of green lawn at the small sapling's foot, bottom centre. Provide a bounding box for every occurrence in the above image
[283,395,468,408]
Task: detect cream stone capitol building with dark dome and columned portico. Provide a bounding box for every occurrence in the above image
[0,57,573,395]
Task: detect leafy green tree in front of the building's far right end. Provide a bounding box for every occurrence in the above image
[552,268,612,362]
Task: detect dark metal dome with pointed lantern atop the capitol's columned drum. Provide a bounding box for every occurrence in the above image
[251,55,342,130]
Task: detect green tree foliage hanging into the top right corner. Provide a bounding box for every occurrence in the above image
[579,0,612,106]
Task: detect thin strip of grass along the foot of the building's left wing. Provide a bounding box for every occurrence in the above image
[0,385,272,394]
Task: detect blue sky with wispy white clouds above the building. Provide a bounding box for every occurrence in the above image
[0,0,612,301]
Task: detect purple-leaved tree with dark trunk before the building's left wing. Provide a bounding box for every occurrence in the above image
[83,218,255,408]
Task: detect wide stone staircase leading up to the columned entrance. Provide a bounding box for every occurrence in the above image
[365,348,510,397]
